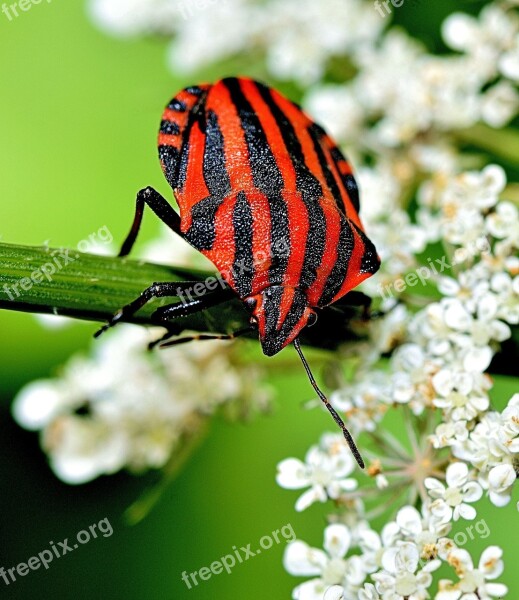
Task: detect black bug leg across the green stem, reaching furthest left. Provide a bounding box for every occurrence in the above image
[94,281,232,337]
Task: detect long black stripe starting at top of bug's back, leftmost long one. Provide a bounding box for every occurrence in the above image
[222,78,290,285]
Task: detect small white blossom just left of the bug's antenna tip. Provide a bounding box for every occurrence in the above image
[276,434,358,511]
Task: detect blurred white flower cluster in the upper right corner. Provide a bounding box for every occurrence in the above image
[306,3,519,151]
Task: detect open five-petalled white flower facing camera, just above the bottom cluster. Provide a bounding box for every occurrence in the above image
[424,462,483,522]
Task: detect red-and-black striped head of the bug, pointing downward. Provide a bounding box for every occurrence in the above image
[245,285,317,356]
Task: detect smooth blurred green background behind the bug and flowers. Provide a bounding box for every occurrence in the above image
[0,0,519,600]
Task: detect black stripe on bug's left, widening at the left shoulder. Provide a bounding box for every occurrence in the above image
[186,110,231,250]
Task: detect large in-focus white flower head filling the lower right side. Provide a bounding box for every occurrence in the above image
[277,158,519,600]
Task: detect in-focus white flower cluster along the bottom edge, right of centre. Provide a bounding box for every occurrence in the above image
[284,506,507,600]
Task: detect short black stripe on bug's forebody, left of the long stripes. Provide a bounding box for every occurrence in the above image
[232,192,254,298]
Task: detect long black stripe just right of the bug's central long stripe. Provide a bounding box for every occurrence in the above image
[256,83,326,289]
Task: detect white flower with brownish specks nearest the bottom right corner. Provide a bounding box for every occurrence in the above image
[436,546,508,600]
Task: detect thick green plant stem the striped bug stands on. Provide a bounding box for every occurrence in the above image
[0,244,252,333]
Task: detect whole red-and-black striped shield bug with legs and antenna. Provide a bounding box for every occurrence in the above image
[96,77,380,467]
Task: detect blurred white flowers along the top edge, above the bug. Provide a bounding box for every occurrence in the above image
[90,0,383,85]
